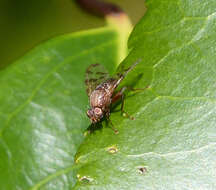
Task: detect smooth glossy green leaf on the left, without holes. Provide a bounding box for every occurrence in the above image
[0,27,122,190]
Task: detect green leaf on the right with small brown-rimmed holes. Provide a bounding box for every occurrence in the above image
[73,0,216,190]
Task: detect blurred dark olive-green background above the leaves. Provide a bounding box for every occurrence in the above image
[0,0,145,68]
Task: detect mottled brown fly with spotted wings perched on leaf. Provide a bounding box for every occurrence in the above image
[85,61,139,131]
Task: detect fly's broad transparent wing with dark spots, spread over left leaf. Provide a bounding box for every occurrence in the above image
[85,63,109,96]
